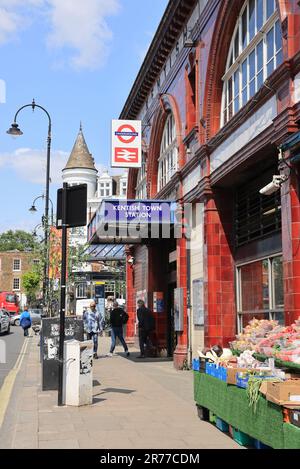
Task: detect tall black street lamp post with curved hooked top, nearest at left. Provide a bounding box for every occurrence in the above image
[7,100,52,312]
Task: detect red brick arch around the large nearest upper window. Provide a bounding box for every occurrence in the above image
[203,0,287,141]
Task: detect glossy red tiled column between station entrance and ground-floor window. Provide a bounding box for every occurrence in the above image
[204,192,236,346]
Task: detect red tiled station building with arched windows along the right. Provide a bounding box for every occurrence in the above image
[88,0,300,369]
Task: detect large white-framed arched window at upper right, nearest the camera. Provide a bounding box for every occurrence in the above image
[221,0,283,125]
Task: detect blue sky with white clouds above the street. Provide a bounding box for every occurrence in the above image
[0,0,168,233]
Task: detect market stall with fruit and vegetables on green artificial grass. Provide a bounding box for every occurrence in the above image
[193,320,300,449]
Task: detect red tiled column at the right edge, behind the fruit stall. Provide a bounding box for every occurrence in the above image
[281,173,300,325]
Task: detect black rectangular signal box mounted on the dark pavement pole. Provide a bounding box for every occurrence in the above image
[56,184,87,229]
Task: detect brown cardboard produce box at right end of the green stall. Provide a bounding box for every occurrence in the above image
[264,379,300,407]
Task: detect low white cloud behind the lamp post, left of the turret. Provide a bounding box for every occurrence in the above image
[0,148,69,184]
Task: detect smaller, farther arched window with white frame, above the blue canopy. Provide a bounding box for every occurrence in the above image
[157,113,178,191]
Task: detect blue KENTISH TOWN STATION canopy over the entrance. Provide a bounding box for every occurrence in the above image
[88,199,182,245]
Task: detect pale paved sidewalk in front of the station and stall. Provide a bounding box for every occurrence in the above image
[0,337,240,449]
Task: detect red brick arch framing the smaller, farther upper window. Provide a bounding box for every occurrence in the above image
[147,93,185,197]
